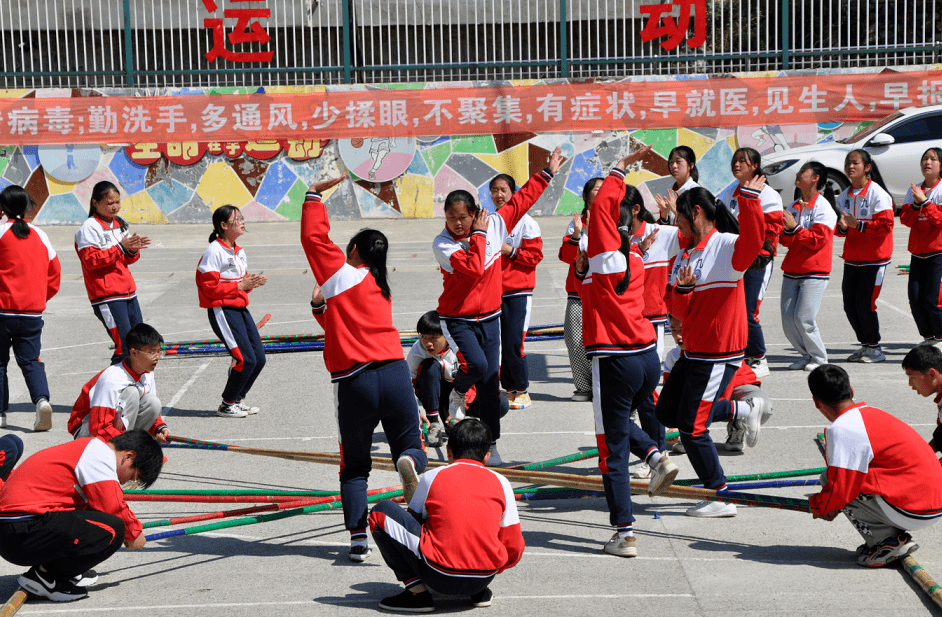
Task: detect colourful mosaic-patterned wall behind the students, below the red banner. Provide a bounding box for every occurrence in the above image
[0,67,936,225]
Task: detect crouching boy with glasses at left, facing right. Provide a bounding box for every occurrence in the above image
[68,323,170,443]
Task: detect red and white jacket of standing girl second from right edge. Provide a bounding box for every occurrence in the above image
[835,180,893,266]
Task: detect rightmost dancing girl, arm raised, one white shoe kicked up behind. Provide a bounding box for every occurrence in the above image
[656,176,765,516]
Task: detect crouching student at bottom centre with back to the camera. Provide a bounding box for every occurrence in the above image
[370,418,524,613]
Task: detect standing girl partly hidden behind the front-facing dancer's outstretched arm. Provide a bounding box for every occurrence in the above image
[490,174,543,409]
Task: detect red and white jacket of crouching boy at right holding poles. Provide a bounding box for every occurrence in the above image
[810,402,942,529]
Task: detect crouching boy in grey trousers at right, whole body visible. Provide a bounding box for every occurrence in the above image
[808,364,942,568]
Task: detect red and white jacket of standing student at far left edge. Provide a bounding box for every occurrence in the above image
[0,222,62,317]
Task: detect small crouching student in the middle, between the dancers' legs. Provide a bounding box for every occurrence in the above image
[406,311,460,448]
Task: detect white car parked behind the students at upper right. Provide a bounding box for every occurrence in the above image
[762,105,942,208]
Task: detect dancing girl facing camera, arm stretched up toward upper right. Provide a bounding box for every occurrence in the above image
[432,148,562,466]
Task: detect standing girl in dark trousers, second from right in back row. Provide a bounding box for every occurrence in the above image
[836,150,893,362]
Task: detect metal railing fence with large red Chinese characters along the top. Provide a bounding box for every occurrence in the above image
[0,0,942,89]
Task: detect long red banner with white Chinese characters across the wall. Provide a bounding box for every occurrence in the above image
[0,71,942,145]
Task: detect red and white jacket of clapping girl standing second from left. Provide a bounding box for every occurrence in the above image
[75,214,141,305]
